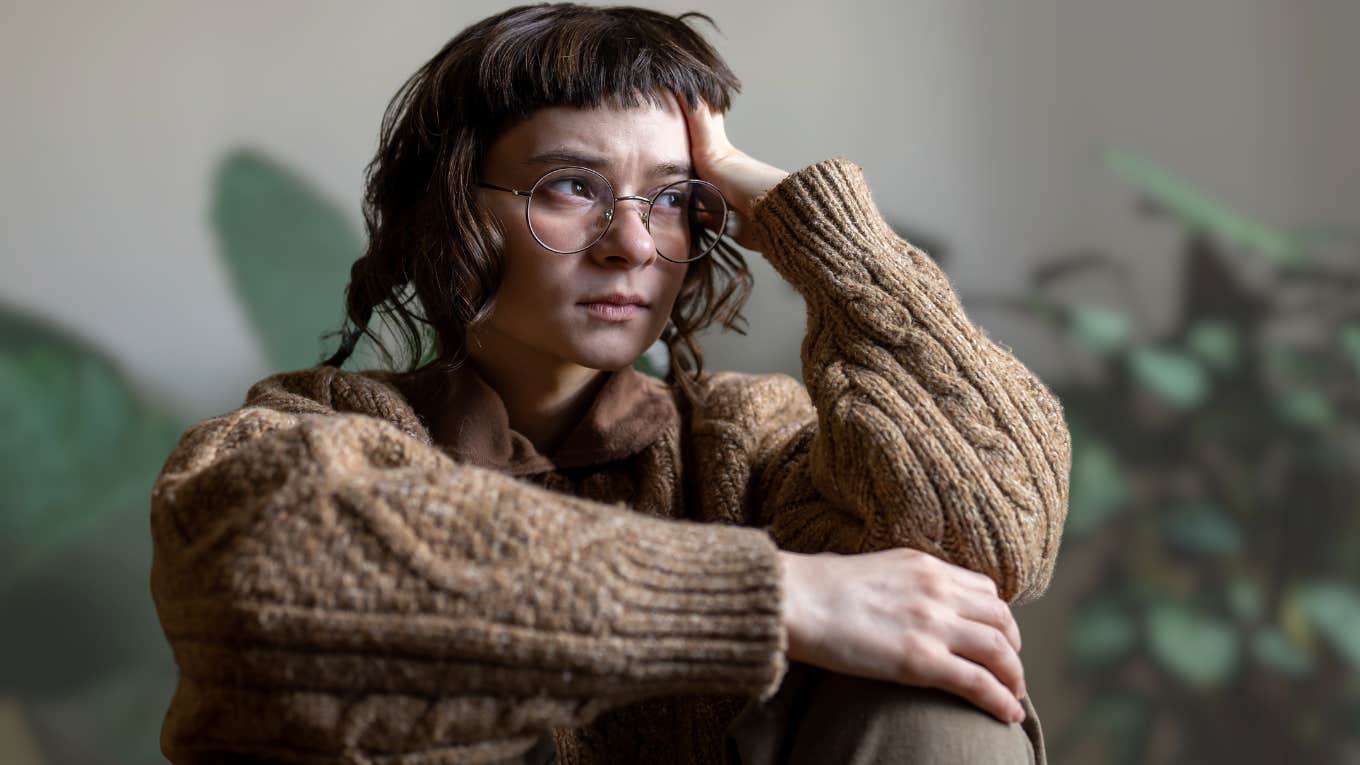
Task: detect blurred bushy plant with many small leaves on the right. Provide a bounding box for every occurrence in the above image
[968,152,1360,762]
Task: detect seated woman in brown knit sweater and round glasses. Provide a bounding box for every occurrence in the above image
[152,5,1070,764]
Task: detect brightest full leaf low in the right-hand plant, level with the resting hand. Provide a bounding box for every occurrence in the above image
[1145,602,1240,690]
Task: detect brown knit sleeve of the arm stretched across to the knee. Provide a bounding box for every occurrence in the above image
[151,368,785,765]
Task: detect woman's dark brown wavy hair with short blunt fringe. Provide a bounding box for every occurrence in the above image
[322,4,752,393]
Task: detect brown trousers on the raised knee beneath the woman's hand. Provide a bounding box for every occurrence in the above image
[524,662,1047,765]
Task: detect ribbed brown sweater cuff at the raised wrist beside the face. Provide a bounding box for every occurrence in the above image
[751,158,898,302]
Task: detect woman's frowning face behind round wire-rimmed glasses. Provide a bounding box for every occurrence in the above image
[468,98,694,372]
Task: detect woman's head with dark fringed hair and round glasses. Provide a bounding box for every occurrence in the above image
[326,5,751,400]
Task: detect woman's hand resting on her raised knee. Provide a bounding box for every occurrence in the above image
[779,549,1025,723]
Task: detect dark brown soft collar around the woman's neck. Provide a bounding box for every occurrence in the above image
[394,362,677,475]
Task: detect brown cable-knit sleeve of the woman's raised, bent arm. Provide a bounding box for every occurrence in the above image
[728,159,1072,603]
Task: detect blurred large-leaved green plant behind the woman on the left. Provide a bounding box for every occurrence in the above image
[0,145,371,765]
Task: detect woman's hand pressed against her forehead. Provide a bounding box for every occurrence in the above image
[676,93,789,250]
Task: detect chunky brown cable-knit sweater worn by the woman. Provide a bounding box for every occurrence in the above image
[151,159,1070,765]
